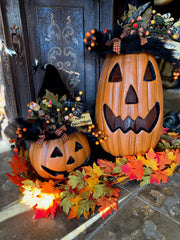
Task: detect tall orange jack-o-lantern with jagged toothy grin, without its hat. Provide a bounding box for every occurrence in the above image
[95,52,163,156]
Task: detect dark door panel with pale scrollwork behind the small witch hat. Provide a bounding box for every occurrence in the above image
[21,0,99,108]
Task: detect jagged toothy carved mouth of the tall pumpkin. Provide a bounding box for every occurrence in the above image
[103,102,160,133]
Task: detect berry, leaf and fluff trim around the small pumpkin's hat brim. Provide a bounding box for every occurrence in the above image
[10,90,84,152]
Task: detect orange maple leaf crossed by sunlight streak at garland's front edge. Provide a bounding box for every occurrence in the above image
[96,196,118,219]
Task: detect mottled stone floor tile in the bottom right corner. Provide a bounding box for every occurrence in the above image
[89,198,180,240]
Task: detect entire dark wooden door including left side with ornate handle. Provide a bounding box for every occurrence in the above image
[0,0,113,119]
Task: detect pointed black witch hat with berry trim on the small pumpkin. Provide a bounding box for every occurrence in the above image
[9,64,84,148]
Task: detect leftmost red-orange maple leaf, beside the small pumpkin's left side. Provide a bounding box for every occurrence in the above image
[9,153,27,175]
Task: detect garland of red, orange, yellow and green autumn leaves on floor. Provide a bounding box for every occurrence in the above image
[7,132,180,219]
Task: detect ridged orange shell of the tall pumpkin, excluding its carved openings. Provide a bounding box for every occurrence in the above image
[95,52,163,156]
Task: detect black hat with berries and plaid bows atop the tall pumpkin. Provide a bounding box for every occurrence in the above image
[84,0,180,66]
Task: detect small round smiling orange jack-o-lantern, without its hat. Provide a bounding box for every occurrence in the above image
[29,132,90,180]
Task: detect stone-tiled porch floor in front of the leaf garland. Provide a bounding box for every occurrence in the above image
[0,91,180,240]
